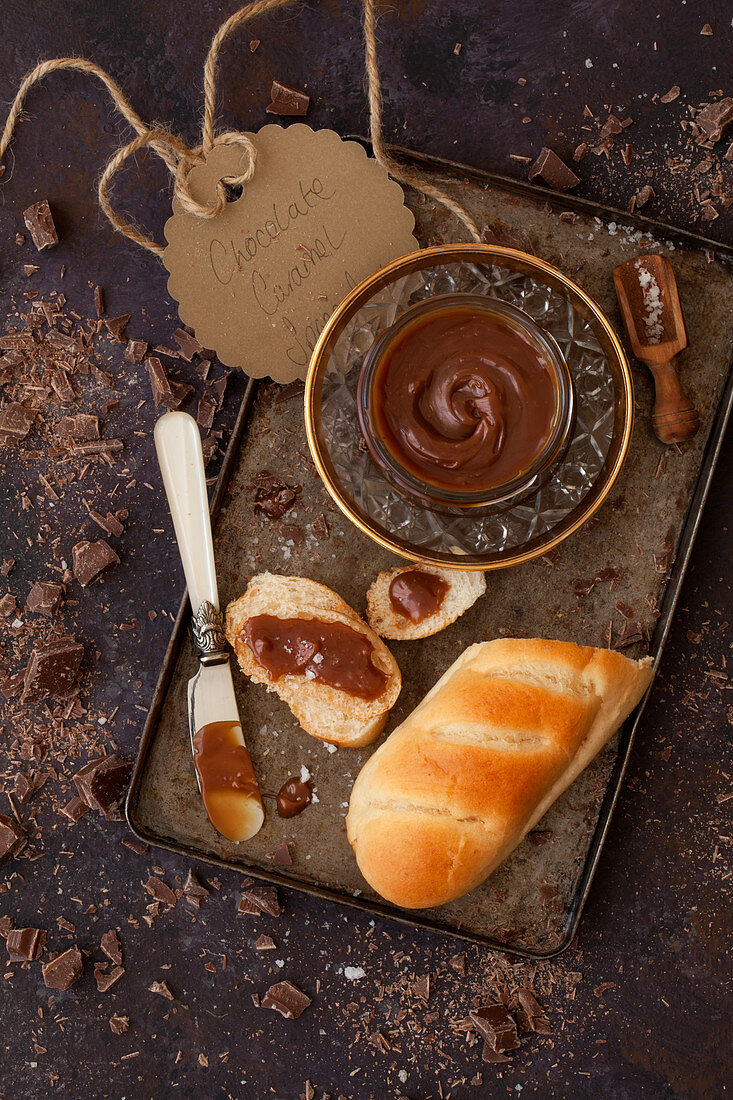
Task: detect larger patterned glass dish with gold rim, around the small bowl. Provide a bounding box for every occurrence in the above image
[305,244,634,570]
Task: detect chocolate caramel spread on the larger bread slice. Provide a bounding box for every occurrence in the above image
[240,615,389,700]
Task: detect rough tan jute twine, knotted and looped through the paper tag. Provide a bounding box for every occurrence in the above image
[0,0,480,255]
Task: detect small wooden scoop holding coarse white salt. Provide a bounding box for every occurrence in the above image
[613,253,700,443]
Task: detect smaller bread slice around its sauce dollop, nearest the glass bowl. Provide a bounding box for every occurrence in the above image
[367,565,486,641]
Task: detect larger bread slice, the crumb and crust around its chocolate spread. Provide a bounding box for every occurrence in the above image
[226,573,402,746]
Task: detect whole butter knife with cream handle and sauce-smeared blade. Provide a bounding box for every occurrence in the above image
[155,413,264,842]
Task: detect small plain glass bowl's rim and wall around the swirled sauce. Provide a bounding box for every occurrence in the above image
[357,294,575,510]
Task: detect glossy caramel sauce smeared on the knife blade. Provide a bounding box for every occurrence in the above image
[194,722,261,836]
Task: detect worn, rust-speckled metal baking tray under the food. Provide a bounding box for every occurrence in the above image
[127,144,733,958]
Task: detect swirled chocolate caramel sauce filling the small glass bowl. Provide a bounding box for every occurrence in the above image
[373,306,556,491]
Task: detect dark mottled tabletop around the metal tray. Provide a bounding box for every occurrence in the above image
[0,0,733,1100]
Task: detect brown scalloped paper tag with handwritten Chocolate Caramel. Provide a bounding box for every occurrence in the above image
[163,123,418,383]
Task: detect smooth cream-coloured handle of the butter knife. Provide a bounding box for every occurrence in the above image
[155,413,219,614]
